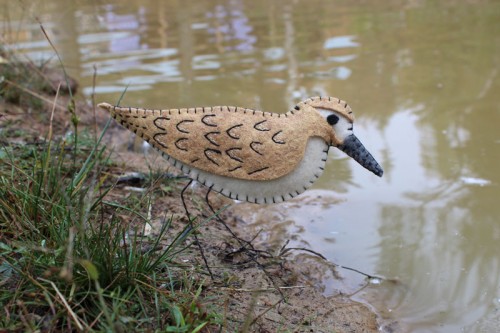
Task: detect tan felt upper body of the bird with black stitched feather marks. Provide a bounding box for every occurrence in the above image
[99,97,352,180]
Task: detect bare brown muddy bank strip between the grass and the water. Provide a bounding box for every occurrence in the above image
[0,69,379,332]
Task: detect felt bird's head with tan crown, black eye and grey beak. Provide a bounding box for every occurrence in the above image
[298,97,384,177]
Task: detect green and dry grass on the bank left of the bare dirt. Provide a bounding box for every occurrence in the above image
[0,121,214,332]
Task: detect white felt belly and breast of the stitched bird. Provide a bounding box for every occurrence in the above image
[156,137,329,204]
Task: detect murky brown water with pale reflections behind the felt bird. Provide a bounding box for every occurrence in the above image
[0,0,500,332]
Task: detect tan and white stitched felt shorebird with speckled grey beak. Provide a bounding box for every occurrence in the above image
[99,97,383,204]
